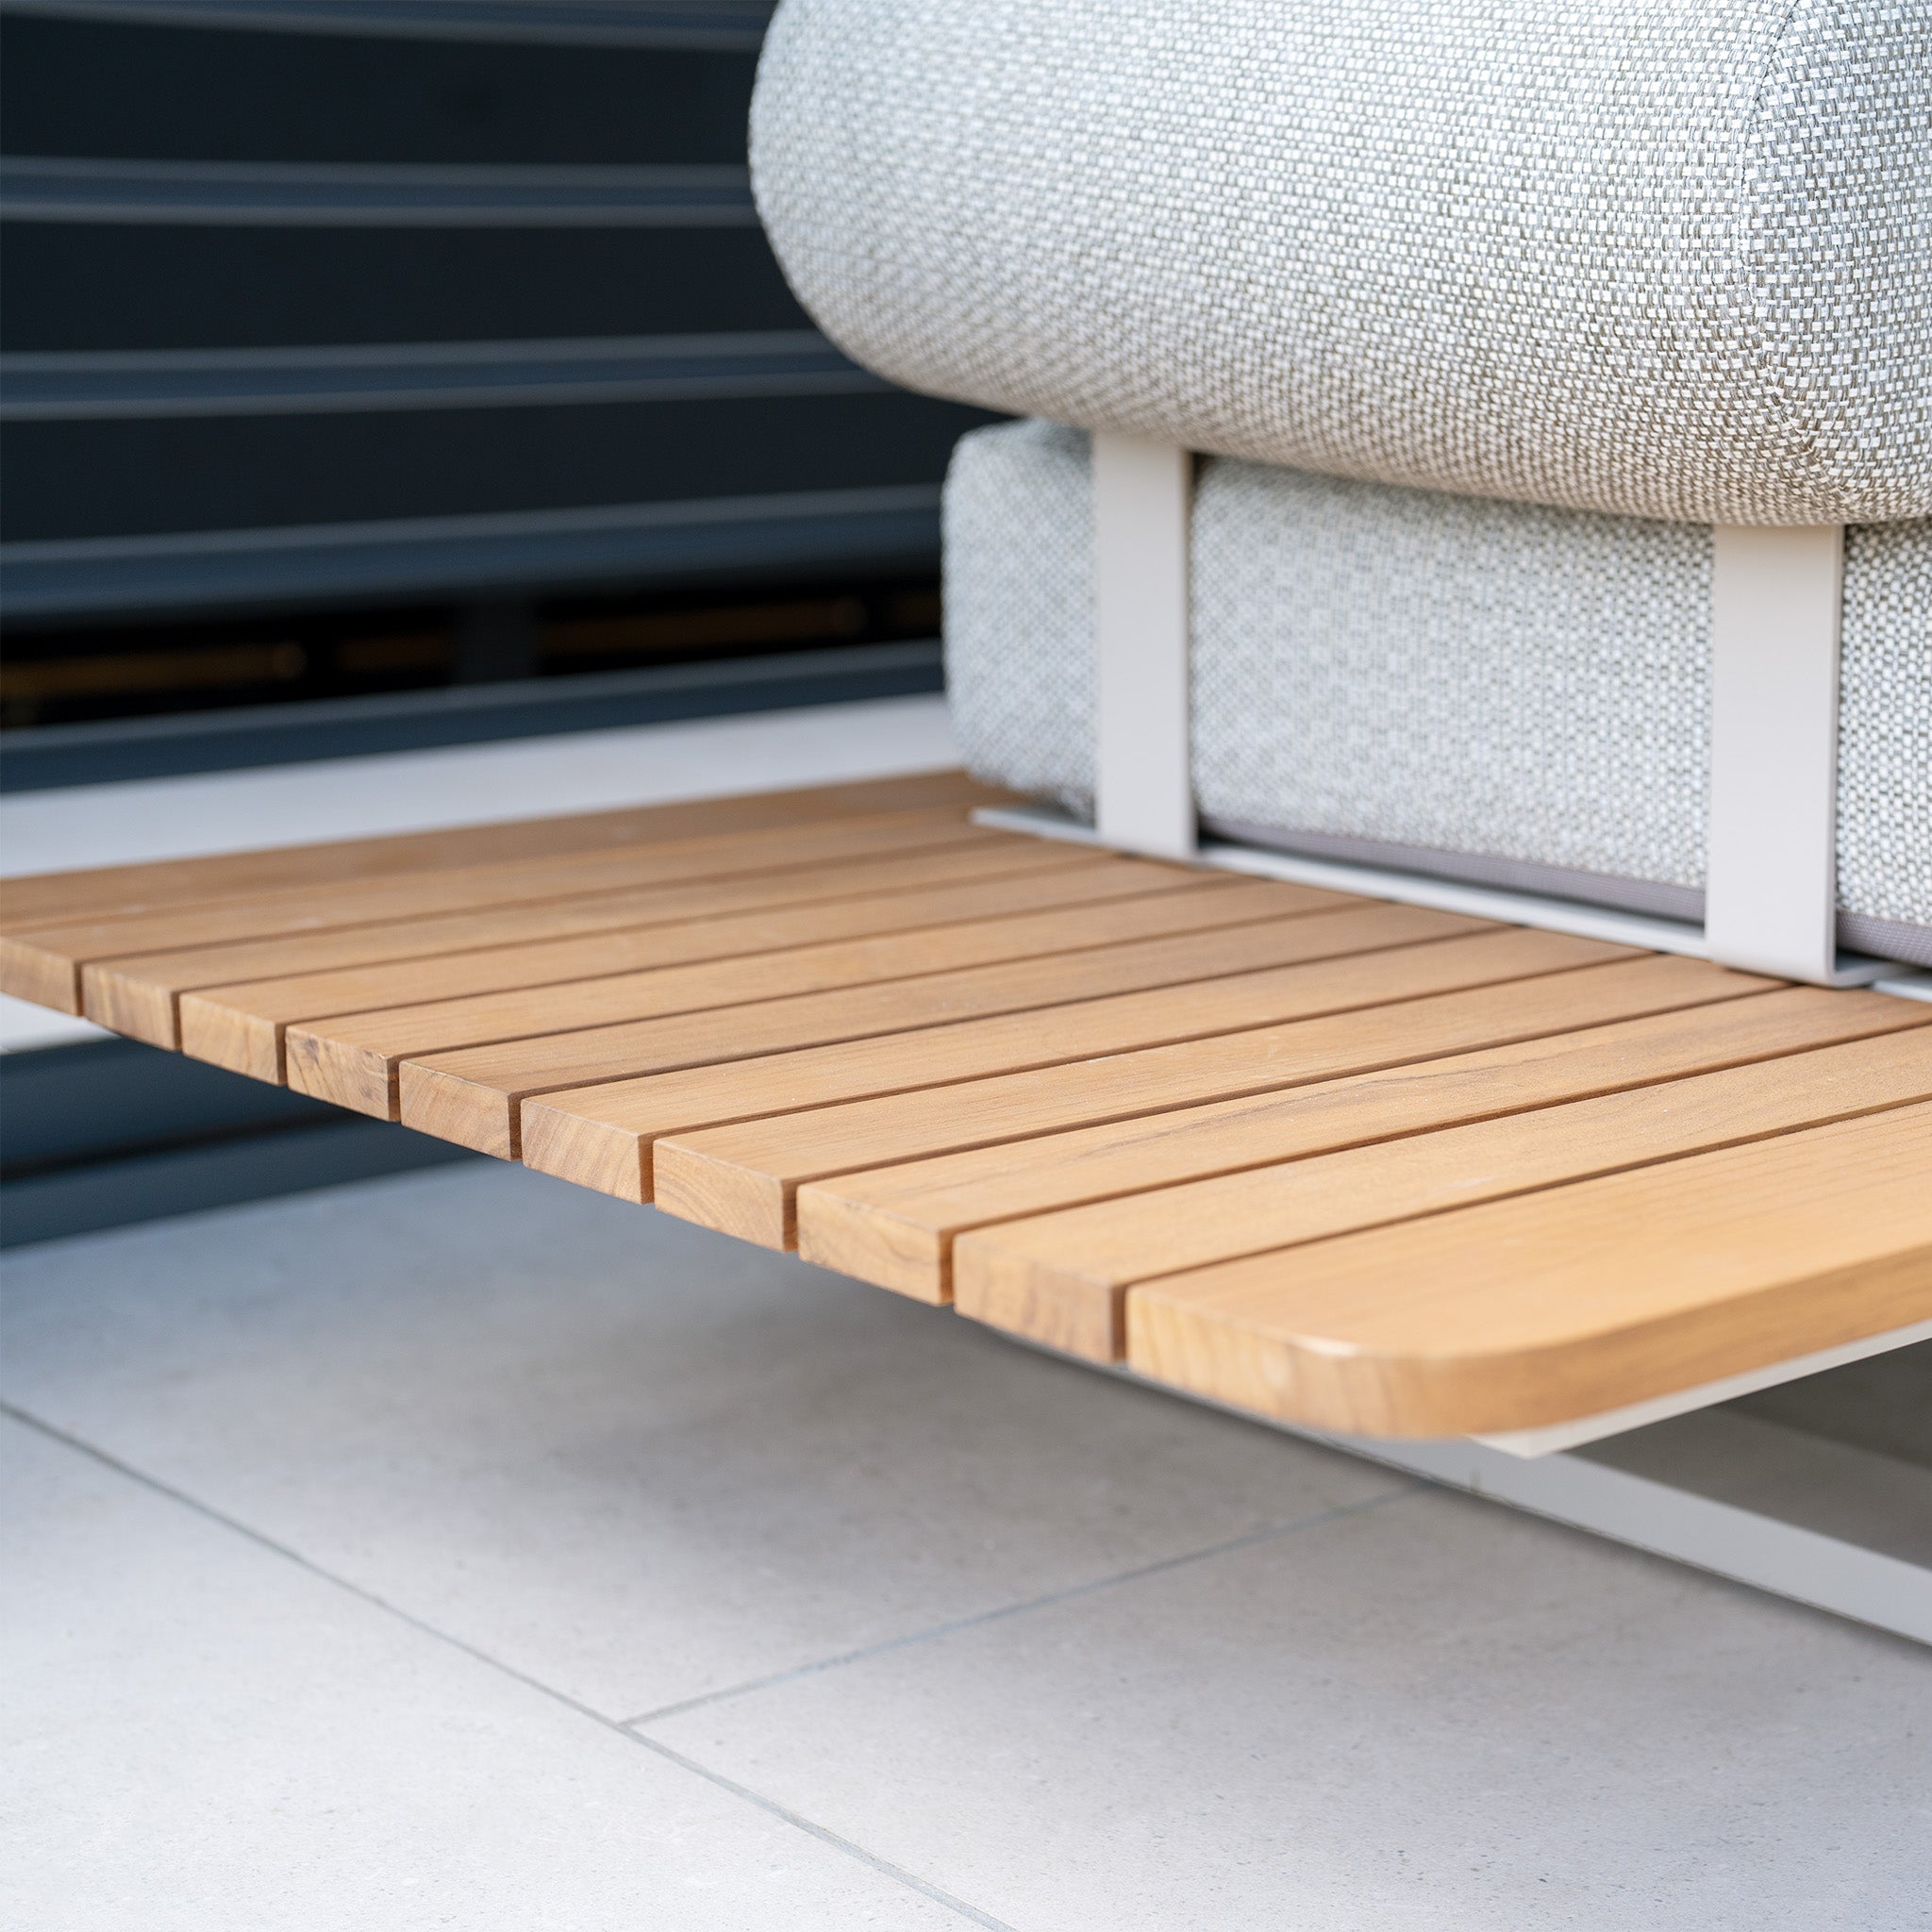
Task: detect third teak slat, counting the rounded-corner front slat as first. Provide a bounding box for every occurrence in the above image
[776,955,1785,1282]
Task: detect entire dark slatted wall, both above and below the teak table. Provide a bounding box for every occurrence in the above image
[0,0,983,1244]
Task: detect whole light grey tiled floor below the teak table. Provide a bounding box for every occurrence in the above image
[0,1163,1932,1932]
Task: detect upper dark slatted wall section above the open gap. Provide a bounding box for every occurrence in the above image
[0,0,979,626]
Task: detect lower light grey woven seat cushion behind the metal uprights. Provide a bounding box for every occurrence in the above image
[947,424,1932,954]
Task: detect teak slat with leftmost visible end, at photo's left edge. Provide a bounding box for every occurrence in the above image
[0,809,1012,1012]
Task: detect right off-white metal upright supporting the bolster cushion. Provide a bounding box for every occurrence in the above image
[1704,524,1845,985]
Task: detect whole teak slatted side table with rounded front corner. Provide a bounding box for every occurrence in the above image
[0,774,1932,1438]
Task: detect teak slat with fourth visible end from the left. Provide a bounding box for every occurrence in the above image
[286,859,1298,1113]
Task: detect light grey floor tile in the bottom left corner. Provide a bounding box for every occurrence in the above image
[0,1420,960,1932]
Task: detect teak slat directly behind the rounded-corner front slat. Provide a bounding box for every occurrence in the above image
[953,993,1932,1360]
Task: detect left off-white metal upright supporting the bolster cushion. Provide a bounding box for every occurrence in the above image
[1093,435,1196,858]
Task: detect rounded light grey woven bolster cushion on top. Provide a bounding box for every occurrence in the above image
[752,0,1932,524]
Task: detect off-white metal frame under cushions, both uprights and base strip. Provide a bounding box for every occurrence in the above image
[977,433,1901,999]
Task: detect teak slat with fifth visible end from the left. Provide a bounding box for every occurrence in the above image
[395,907,1484,1158]
